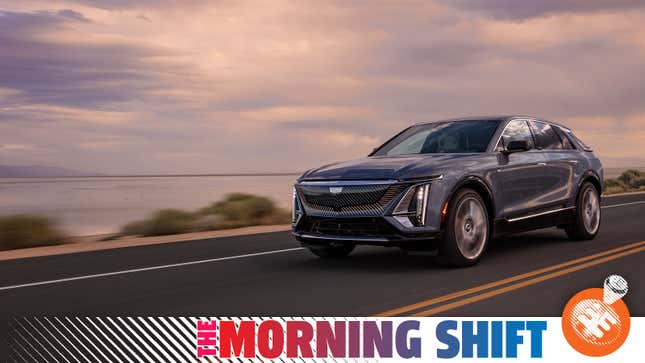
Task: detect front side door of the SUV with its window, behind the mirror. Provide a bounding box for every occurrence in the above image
[492,119,546,218]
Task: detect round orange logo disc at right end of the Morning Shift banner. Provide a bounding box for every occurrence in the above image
[562,288,630,357]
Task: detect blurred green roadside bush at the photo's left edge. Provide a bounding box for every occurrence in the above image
[0,214,65,251]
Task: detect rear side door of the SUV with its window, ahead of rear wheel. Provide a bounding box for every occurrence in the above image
[529,120,578,207]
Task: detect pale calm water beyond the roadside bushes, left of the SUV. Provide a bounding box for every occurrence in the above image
[0,175,297,235]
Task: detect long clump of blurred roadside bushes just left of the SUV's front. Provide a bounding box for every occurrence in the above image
[119,193,291,236]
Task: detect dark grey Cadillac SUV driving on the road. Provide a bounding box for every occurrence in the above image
[292,116,603,266]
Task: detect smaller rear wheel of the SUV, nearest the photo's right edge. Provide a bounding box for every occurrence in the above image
[564,182,602,241]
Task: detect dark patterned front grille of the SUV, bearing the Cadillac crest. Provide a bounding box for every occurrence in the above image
[298,183,409,217]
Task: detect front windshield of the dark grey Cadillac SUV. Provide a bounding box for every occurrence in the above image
[373,120,499,156]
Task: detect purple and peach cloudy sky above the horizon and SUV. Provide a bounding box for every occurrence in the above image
[0,0,645,174]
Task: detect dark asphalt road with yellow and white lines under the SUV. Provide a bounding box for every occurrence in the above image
[0,194,645,318]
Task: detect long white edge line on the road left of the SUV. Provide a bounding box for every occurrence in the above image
[0,247,304,291]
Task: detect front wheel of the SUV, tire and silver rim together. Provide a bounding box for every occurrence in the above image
[437,189,490,267]
